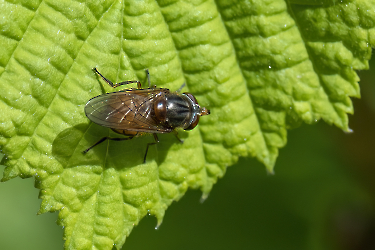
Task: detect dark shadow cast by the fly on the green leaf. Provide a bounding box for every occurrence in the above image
[52,123,182,169]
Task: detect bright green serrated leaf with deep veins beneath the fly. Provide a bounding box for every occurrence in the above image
[0,0,375,249]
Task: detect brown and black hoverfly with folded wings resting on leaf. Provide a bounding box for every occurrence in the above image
[83,68,210,163]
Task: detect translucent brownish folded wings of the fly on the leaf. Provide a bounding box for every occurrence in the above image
[85,89,172,133]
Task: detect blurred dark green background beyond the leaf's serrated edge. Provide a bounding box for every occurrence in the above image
[0,57,375,250]
